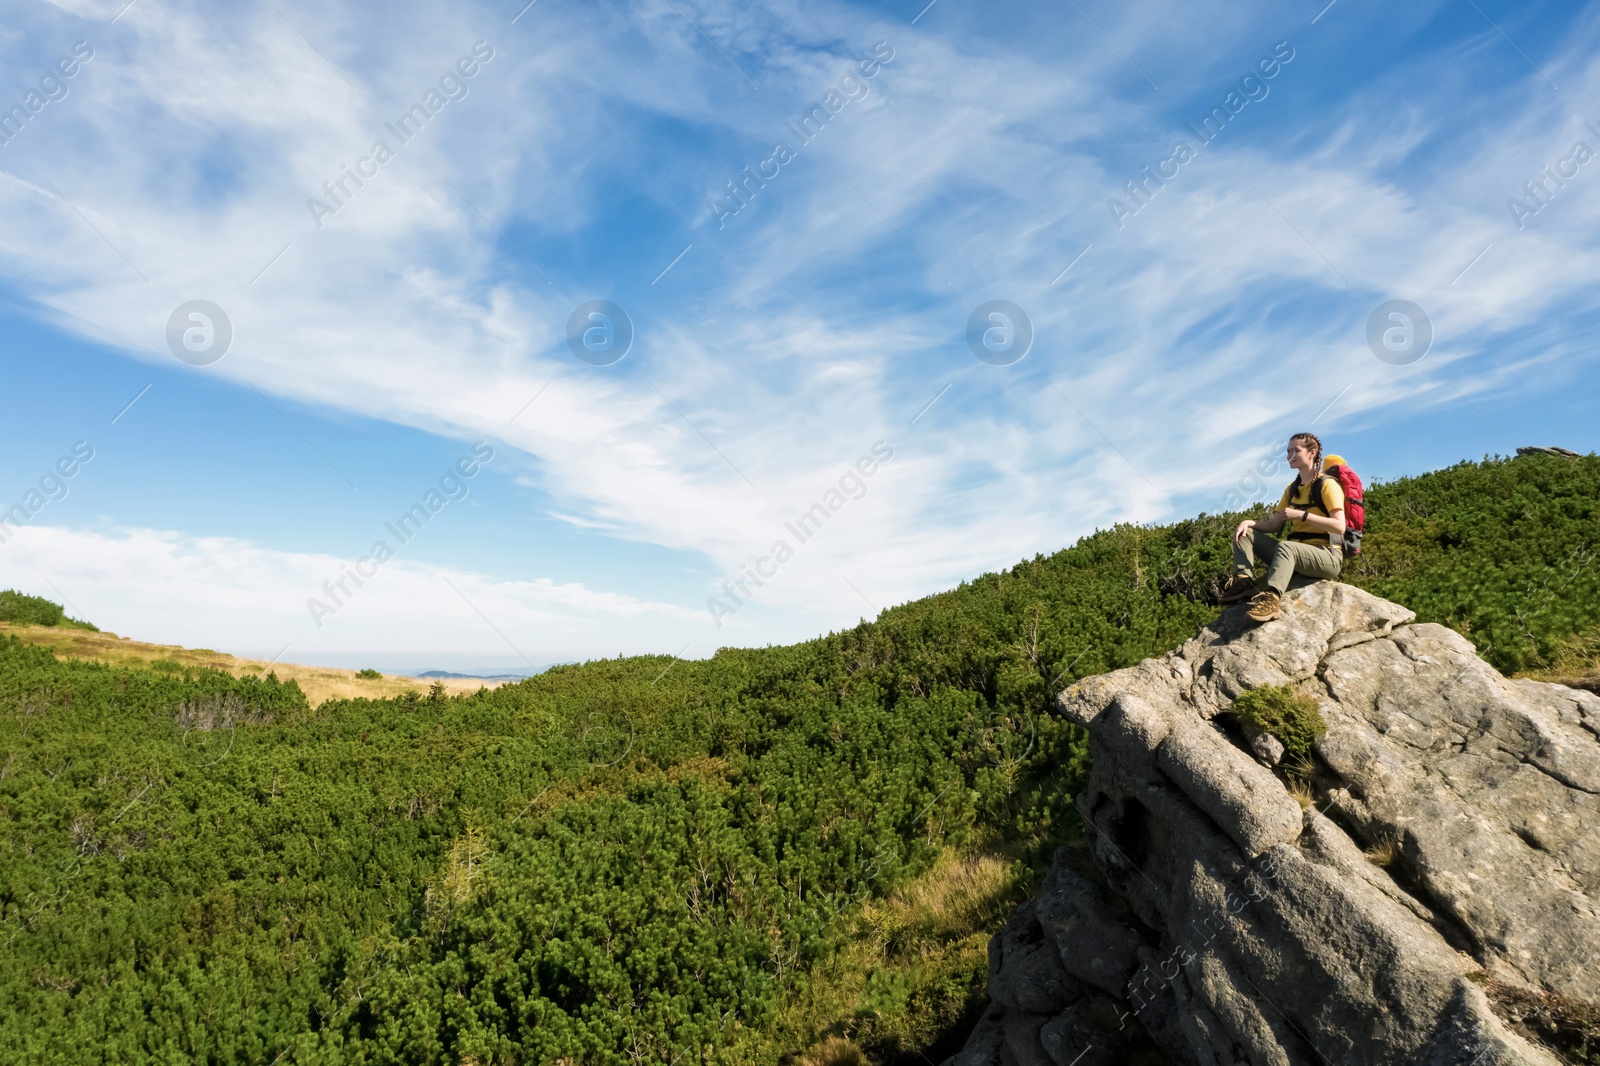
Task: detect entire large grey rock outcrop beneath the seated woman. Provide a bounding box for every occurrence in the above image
[950,581,1600,1066]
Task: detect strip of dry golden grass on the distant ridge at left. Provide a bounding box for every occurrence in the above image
[0,623,501,707]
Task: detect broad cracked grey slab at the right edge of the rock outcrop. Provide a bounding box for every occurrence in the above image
[1317,626,1600,1000]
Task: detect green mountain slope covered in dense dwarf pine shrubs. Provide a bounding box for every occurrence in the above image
[0,456,1600,1064]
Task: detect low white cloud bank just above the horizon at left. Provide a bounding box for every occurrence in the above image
[0,525,704,669]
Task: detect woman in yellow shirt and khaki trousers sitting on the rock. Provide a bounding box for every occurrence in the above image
[1222,434,1344,621]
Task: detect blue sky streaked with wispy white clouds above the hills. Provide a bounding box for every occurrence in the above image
[0,0,1600,671]
